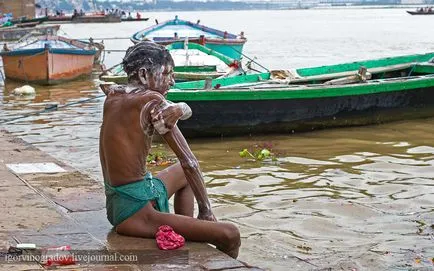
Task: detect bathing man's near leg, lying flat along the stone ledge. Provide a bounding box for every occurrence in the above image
[116,204,241,258]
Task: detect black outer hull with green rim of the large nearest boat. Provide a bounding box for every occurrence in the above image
[168,78,434,138]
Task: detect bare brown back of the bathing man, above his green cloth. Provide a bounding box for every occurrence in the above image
[100,91,162,186]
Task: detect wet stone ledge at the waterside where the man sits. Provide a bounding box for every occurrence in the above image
[0,131,260,271]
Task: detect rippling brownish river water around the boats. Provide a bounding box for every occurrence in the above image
[0,9,434,270]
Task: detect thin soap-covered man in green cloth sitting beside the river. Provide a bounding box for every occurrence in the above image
[100,42,241,258]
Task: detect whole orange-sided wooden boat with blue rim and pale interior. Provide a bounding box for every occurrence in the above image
[0,36,96,84]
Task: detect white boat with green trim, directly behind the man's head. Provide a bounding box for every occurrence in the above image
[100,41,240,84]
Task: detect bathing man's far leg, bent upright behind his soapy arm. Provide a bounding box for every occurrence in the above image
[156,163,194,217]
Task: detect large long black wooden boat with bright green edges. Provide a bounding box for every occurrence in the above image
[152,53,434,137]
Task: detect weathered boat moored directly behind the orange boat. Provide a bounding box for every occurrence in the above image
[0,25,60,42]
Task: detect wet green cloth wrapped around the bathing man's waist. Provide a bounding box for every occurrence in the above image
[104,172,169,227]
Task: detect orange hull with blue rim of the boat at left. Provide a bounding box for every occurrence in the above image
[2,49,95,85]
